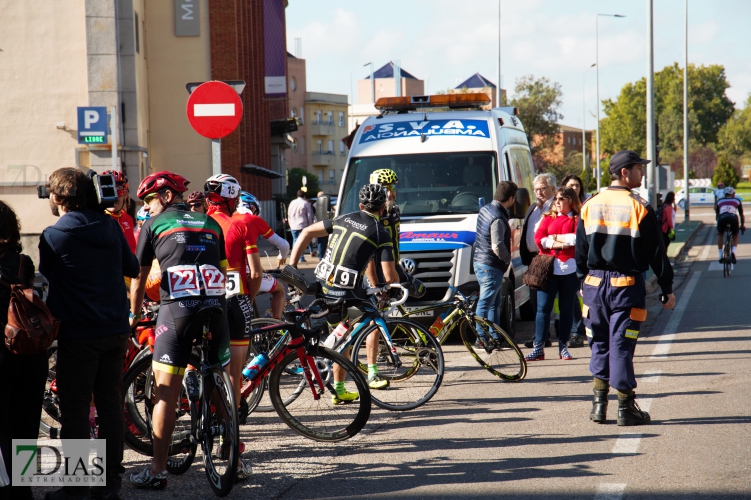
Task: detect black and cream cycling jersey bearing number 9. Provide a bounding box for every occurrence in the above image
[315,212,394,298]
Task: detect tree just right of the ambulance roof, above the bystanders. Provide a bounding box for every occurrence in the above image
[509,75,563,154]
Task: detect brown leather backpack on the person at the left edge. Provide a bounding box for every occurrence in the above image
[0,255,60,355]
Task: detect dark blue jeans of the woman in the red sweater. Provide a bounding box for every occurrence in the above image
[535,273,579,349]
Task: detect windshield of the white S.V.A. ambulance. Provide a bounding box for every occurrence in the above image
[339,151,498,215]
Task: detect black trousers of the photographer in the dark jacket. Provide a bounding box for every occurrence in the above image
[57,333,130,495]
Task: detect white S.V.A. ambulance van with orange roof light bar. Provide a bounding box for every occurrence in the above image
[337,94,533,335]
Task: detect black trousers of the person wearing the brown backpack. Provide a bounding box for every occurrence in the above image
[0,345,48,500]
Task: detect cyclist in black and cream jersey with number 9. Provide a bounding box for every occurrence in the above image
[290,184,399,404]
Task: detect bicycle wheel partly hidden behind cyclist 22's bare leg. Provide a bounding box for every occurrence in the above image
[122,353,199,474]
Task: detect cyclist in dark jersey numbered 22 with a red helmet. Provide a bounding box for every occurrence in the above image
[130,171,230,489]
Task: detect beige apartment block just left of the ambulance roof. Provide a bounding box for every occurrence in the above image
[305,92,349,195]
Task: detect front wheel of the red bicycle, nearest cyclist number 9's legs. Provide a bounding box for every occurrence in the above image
[269,346,371,442]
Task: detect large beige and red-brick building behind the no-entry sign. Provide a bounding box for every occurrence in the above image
[0,0,294,258]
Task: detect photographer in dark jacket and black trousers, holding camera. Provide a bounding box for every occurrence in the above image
[39,168,140,499]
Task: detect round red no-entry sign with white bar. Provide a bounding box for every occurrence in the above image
[187,81,243,139]
